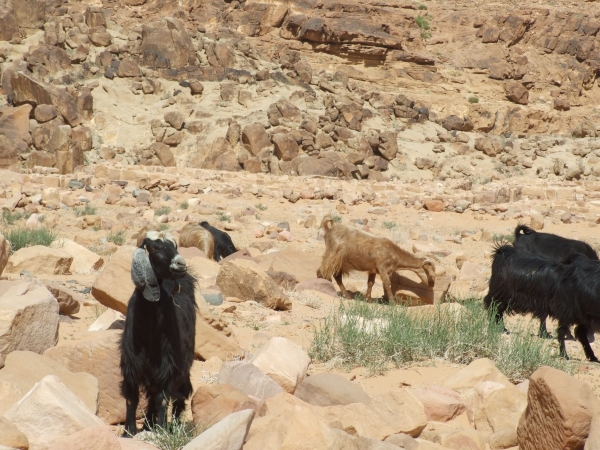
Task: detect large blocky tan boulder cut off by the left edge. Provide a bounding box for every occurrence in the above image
[0,281,59,355]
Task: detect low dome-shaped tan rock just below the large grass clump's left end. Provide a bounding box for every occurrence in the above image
[294,373,371,406]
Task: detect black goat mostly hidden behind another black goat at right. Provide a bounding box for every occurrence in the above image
[513,225,598,338]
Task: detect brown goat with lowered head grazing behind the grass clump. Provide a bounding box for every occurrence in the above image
[317,216,435,303]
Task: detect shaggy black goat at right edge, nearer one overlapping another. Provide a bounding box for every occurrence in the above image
[484,244,600,362]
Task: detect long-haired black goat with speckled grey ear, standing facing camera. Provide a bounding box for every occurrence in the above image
[120,231,196,436]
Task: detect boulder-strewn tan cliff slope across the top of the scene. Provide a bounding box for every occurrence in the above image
[0,0,600,182]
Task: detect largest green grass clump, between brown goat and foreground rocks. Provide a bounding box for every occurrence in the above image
[309,299,572,382]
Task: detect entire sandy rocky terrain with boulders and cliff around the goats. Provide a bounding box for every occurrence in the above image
[0,0,600,450]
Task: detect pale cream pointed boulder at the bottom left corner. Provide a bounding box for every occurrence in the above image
[4,375,103,450]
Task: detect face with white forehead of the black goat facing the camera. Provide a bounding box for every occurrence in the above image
[142,231,187,280]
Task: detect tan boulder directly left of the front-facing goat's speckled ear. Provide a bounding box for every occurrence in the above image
[92,245,136,314]
